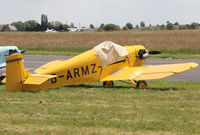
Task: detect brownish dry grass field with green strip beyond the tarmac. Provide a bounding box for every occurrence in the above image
[0,30,200,58]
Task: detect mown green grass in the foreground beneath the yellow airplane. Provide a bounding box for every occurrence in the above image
[0,81,200,135]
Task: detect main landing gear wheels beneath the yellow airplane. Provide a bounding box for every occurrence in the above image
[103,80,147,89]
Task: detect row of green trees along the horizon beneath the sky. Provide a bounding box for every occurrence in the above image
[2,14,200,32]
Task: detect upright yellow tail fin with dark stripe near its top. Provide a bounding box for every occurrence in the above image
[6,53,30,92]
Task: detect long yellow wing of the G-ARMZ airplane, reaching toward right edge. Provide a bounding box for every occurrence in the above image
[100,62,198,81]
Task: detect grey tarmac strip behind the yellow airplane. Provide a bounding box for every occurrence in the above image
[1,55,200,82]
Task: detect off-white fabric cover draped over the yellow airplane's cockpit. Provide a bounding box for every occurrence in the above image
[93,41,128,67]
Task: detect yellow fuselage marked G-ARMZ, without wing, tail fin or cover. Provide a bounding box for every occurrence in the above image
[24,45,145,90]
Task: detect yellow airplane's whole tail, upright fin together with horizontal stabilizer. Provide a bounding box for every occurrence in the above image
[6,53,56,92]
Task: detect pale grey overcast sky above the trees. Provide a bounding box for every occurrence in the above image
[0,0,200,27]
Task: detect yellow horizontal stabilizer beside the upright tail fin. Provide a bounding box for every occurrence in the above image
[23,74,56,85]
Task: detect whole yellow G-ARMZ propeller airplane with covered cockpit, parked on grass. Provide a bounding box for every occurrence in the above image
[4,41,198,92]
